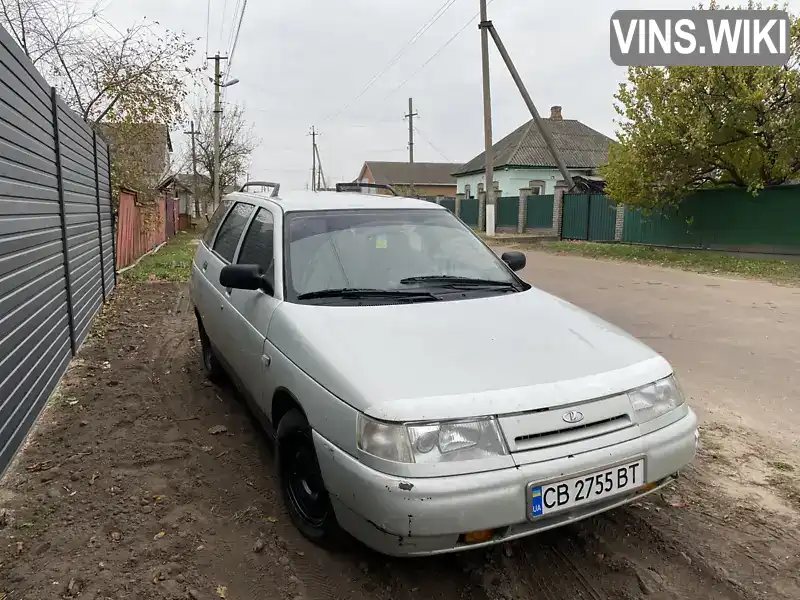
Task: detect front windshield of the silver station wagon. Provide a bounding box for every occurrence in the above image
[285,209,517,301]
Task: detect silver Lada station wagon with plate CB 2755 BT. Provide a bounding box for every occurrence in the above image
[191,184,698,556]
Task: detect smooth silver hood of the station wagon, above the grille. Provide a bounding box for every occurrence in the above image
[269,288,672,421]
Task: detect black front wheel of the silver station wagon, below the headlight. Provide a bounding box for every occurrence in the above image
[275,409,343,549]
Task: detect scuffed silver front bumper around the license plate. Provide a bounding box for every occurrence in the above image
[314,410,697,556]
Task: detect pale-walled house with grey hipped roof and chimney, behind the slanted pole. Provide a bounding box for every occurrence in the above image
[454,106,614,198]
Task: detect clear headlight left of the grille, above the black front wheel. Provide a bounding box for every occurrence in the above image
[358,415,508,463]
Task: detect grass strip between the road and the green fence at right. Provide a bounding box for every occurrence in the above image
[531,242,800,285]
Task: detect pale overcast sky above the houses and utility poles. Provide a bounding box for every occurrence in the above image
[94,0,800,189]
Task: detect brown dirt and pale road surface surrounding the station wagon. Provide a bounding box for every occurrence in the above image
[0,254,800,600]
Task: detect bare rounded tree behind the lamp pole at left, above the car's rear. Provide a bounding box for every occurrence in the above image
[194,103,260,212]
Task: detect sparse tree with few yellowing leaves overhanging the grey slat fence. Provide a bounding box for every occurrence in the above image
[0,0,199,203]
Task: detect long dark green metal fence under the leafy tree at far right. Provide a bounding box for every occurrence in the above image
[622,185,800,247]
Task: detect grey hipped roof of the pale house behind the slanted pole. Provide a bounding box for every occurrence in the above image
[455,119,614,175]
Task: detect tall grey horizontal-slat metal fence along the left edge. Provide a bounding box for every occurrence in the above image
[0,27,116,471]
